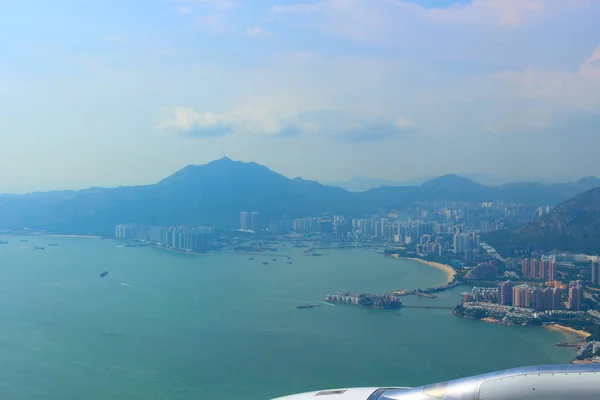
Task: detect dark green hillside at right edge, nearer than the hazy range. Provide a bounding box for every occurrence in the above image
[486,186,600,254]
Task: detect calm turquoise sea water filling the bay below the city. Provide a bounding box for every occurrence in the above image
[0,237,573,400]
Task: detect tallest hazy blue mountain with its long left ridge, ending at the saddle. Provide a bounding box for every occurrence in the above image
[0,158,354,235]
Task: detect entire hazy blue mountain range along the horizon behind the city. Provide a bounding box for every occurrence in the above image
[0,158,600,236]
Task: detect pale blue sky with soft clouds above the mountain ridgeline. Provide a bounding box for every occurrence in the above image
[0,0,600,193]
